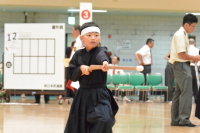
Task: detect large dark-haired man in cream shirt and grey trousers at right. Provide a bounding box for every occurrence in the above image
[170,14,200,127]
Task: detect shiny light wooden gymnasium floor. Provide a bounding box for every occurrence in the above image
[0,99,200,133]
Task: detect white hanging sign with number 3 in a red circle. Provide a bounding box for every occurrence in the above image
[79,3,92,25]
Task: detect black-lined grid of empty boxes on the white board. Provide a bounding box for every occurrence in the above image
[13,38,56,74]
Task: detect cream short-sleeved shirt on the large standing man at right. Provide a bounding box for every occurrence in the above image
[170,27,190,64]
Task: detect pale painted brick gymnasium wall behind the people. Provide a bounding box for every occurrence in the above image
[0,12,200,81]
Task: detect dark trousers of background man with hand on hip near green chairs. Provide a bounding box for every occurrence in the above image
[139,65,151,101]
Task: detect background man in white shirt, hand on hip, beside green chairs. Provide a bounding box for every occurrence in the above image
[135,38,154,102]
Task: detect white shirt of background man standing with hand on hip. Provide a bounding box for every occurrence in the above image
[136,45,152,65]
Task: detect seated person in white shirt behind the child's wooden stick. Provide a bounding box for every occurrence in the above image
[107,56,131,102]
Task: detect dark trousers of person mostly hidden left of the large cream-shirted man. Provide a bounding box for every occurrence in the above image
[165,62,175,101]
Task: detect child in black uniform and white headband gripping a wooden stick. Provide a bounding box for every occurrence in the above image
[64,22,118,133]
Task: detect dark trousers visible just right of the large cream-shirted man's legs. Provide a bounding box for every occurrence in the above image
[190,66,198,102]
